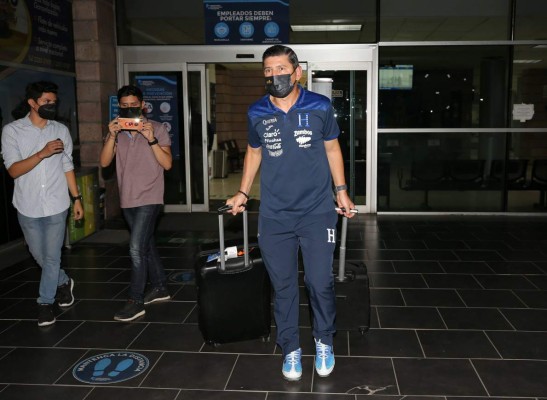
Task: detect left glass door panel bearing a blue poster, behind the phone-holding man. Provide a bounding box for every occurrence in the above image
[124,64,209,212]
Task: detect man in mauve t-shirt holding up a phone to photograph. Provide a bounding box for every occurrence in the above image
[101,85,173,322]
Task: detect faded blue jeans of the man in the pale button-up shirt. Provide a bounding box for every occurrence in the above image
[17,209,68,304]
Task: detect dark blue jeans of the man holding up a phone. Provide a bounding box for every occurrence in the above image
[122,204,166,302]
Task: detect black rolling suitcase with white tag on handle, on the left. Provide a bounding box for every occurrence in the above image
[195,207,271,345]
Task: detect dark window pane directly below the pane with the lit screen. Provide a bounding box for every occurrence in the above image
[378,131,508,212]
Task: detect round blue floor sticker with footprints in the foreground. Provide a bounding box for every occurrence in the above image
[72,351,149,385]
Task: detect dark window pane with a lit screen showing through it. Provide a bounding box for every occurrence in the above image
[378,46,510,128]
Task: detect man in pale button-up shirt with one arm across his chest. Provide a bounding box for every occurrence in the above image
[2,82,84,326]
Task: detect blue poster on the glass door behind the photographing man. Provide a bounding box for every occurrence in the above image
[135,74,180,159]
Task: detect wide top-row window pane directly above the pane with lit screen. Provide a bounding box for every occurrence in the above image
[380,0,512,42]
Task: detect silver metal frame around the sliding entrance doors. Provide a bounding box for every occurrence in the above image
[117,44,378,213]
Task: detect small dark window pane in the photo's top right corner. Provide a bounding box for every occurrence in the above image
[514,0,547,40]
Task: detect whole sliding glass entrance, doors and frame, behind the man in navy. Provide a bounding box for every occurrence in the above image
[118,45,376,213]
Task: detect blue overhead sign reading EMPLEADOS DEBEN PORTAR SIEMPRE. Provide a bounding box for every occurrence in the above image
[203,0,289,44]
